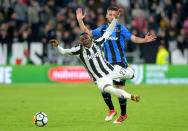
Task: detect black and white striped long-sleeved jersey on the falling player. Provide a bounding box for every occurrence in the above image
[57,19,117,81]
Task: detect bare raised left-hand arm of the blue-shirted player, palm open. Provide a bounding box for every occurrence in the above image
[76,8,92,37]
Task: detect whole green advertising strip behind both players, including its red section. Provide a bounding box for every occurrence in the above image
[0,64,188,84]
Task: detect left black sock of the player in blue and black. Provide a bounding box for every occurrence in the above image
[102,92,114,110]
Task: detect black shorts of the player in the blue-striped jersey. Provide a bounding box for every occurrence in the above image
[111,62,128,86]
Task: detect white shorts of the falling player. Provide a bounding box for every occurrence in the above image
[96,65,134,91]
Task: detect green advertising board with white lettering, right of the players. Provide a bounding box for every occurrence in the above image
[131,64,188,84]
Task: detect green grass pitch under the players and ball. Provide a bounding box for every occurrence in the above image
[0,83,188,131]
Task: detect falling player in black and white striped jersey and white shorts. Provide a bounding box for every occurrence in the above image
[50,19,140,122]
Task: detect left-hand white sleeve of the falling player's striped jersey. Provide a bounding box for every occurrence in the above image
[56,45,81,55]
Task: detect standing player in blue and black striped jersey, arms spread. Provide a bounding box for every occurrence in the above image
[76,7,156,123]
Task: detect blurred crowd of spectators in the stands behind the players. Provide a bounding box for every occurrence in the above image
[0,0,188,64]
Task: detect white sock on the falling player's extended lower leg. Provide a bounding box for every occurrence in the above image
[104,86,131,99]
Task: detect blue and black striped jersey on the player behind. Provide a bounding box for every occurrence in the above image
[92,23,132,63]
